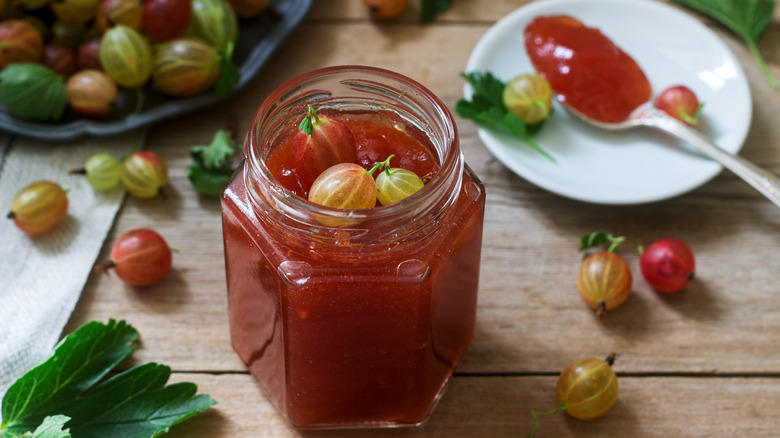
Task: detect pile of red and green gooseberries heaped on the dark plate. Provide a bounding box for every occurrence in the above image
[0,0,268,118]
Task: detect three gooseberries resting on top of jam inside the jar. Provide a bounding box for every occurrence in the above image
[292,106,424,210]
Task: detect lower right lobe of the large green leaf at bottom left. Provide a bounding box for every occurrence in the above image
[58,363,216,438]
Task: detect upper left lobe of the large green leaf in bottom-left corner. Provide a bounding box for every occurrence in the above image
[0,320,138,436]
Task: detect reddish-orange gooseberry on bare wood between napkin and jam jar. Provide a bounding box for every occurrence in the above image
[95,228,173,286]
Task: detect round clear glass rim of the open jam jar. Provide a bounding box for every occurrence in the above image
[244,65,463,223]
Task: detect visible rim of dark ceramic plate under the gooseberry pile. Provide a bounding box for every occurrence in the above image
[0,0,313,140]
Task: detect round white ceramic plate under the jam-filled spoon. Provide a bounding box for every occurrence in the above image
[464,0,752,204]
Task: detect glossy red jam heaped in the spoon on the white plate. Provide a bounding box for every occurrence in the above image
[525,15,652,123]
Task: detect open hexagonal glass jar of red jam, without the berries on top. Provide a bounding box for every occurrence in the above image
[222,66,485,428]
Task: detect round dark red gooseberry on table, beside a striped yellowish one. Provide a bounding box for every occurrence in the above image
[639,238,696,293]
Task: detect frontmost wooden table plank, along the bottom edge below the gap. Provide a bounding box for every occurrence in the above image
[163,374,780,438]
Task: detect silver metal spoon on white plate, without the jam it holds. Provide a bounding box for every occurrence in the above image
[561,101,780,207]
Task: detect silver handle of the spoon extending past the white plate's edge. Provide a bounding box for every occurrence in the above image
[642,109,780,207]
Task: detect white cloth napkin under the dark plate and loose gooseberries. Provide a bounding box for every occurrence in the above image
[0,130,146,397]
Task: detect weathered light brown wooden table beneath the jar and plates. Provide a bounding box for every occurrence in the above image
[56,0,780,438]
